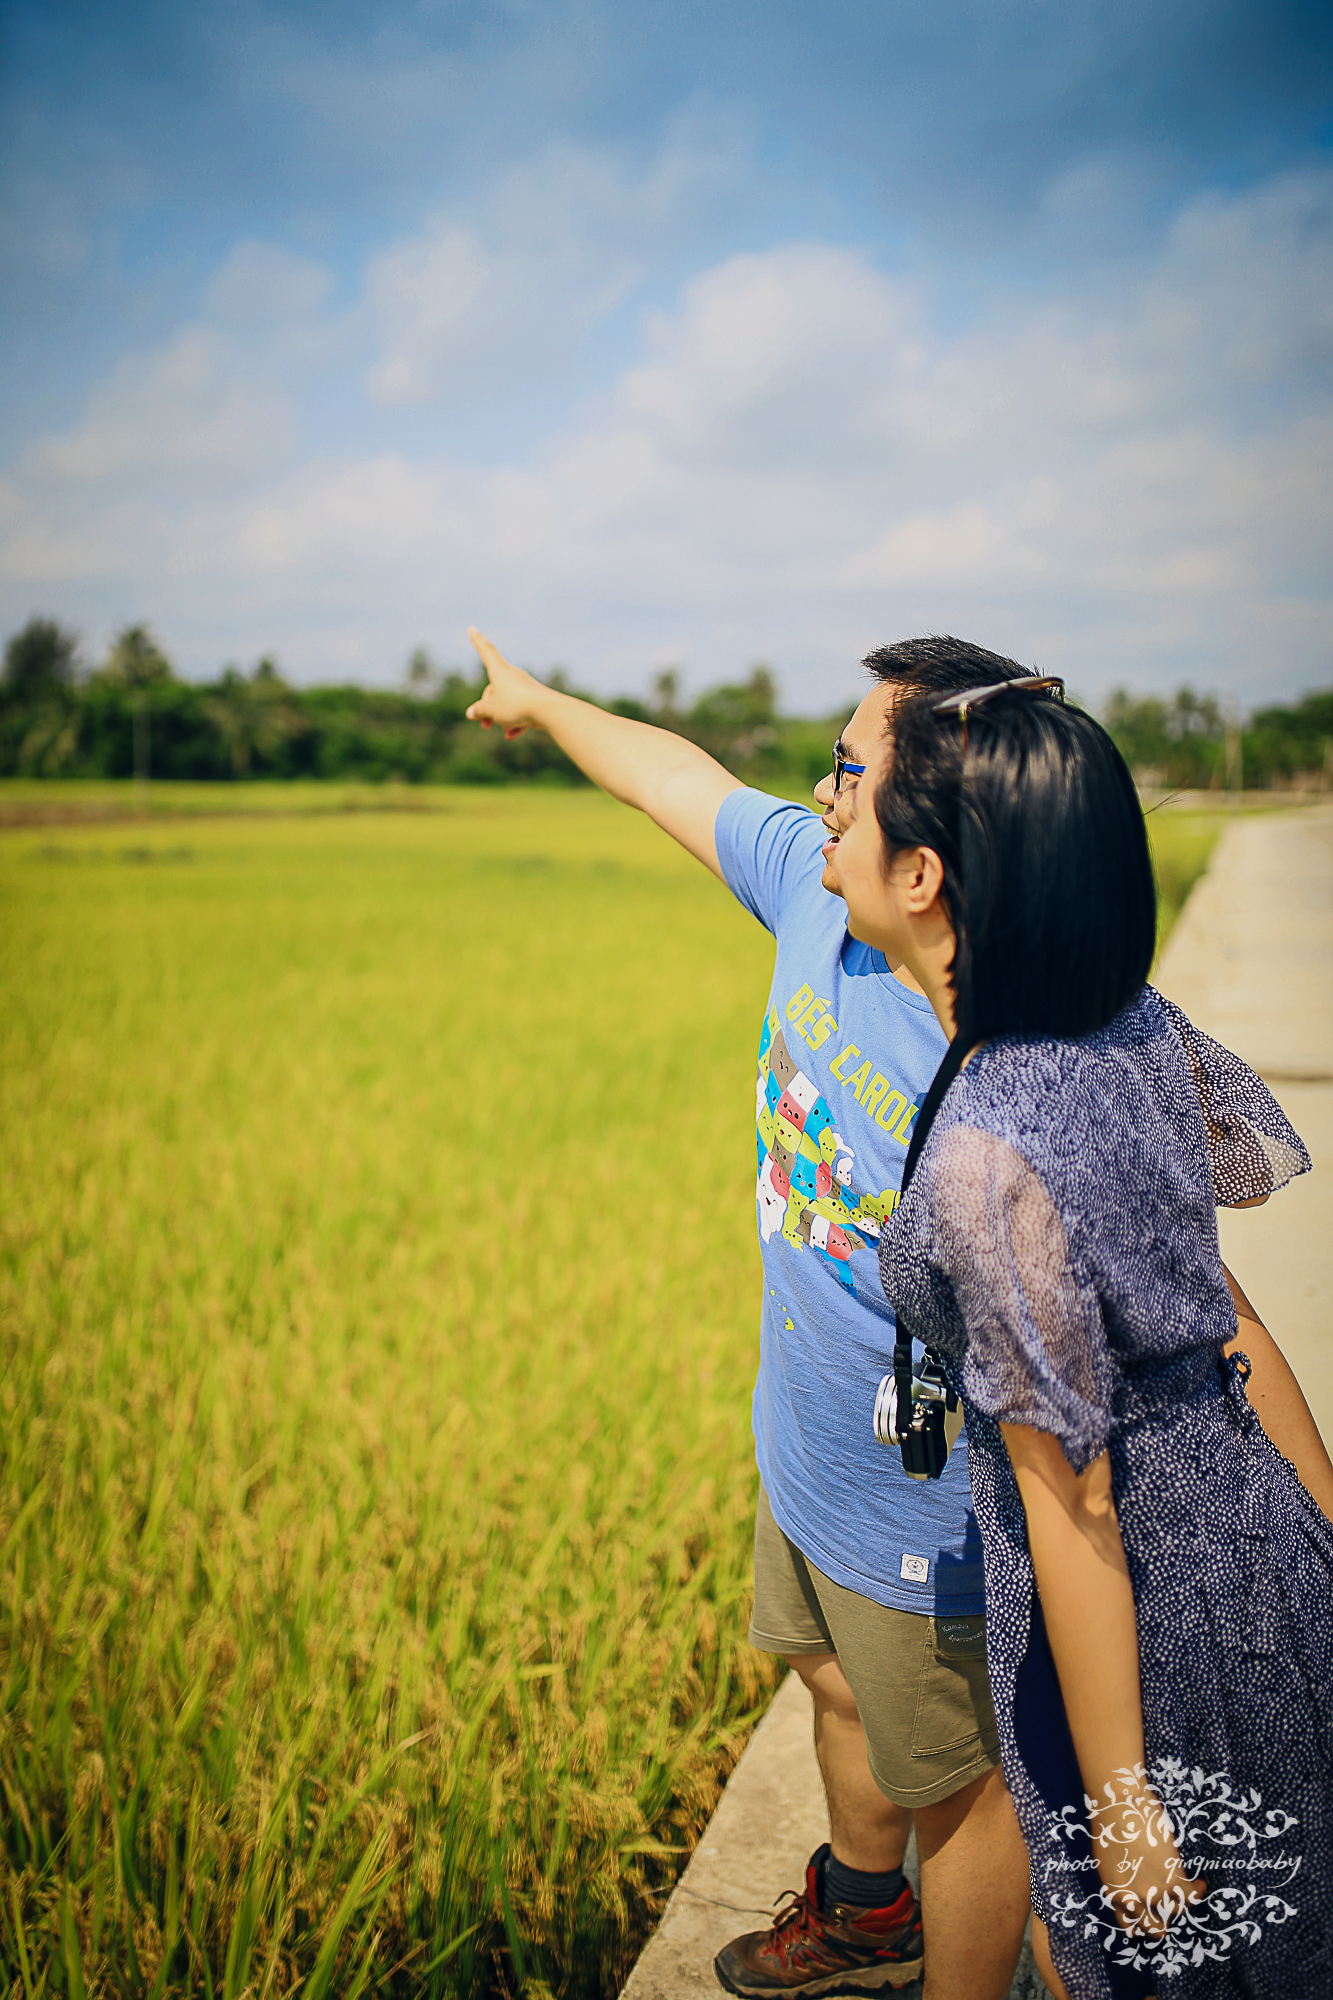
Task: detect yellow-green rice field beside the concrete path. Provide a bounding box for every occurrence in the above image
[0,786,1217,2000]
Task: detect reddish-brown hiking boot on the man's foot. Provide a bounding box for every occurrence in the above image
[713,1844,923,2000]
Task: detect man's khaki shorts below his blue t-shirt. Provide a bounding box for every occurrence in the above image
[751,1486,999,1808]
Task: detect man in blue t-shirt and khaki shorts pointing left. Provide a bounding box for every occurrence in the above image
[468,630,1029,2000]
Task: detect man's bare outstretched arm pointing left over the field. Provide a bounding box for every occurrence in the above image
[468,626,741,880]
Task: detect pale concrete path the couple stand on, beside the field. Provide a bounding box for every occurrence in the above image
[624,806,1333,2000]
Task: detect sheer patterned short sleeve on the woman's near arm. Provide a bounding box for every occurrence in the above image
[931,1126,1115,1472]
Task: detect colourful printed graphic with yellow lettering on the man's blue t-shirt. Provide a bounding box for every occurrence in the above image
[755,986,917,1296]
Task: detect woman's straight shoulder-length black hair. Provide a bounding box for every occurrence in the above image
[875,682,1157,1050]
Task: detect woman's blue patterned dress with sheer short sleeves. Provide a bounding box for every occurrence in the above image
[881,986,1333,2000]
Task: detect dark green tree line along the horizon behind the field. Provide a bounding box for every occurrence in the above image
[0,618,1333,790]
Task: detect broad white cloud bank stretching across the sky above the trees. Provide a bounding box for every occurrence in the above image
[0,162,1333,706]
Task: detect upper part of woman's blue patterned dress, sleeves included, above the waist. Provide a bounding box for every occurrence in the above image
[881,986,1309,1464]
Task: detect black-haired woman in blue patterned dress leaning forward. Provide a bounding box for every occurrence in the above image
[831,680,1333,2000]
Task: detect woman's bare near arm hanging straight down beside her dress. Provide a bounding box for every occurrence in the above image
[1001,1424,1203,1930]
